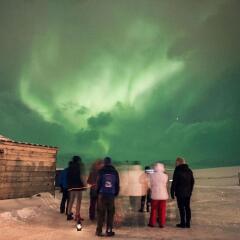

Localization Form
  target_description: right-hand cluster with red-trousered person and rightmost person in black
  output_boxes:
[139,157,194,228]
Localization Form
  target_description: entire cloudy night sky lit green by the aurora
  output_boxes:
[0,0,240,167]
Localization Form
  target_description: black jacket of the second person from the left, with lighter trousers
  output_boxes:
[67,162,84,190]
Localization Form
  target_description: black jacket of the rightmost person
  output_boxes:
[171,164,194,198]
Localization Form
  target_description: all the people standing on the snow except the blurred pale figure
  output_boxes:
[60,156,194,236]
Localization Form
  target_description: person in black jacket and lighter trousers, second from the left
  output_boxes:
[67,156,85,221]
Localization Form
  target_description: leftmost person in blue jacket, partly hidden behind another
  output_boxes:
[59,161,72,213]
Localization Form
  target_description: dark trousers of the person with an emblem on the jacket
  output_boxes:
[97,195,115,233]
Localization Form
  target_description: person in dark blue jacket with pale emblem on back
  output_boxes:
[96,157,120,237]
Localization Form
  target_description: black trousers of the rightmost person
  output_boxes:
[177,197,191,225]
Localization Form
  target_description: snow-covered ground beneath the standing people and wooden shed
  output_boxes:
[0,186,240,240]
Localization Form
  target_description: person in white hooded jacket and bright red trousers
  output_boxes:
[148,163,168,228]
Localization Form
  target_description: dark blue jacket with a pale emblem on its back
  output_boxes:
[97,165,120,197]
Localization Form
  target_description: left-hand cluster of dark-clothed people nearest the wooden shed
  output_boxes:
[60,156,120,236]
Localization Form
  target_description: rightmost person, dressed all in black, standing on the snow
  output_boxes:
[171,157,194,228]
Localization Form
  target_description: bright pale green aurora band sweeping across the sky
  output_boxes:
[20,27,183,131]
